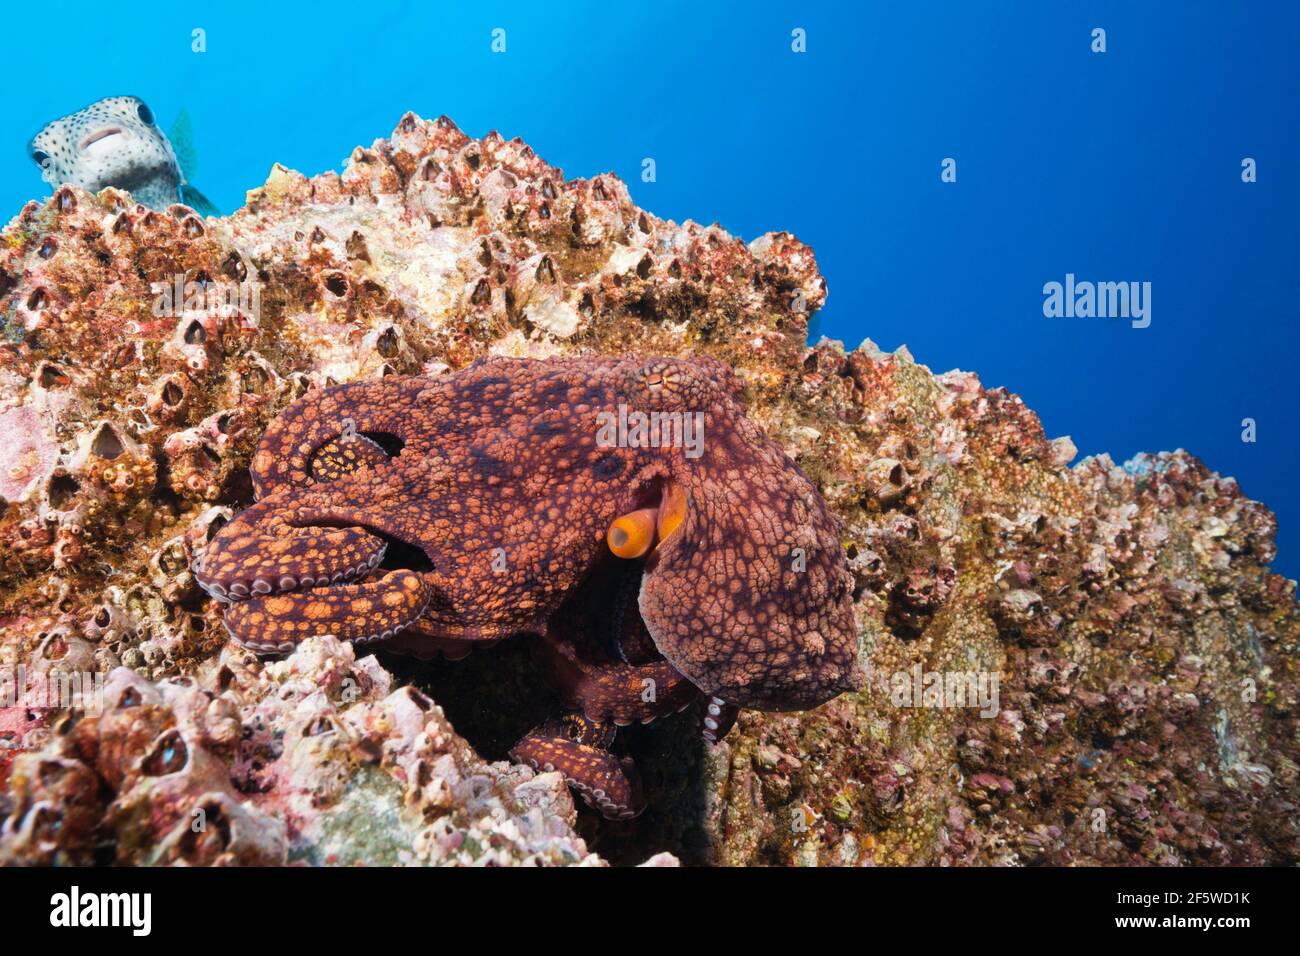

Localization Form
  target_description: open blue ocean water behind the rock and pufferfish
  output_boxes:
[0,0,1300,576]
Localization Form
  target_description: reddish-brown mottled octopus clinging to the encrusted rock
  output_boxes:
[195,355,863,818]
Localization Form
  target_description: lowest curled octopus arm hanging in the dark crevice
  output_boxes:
[510,714,645,819]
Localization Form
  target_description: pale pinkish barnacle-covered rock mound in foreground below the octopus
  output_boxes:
[0,637,601,865]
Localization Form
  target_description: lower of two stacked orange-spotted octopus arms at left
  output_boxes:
[225,568,433,653]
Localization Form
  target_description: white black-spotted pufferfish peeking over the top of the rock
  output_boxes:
[27,96,218,216]
